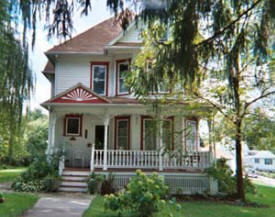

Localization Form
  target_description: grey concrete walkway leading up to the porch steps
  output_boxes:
[23,193,92,217]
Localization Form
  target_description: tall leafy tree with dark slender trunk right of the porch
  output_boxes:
[125,1,275,201]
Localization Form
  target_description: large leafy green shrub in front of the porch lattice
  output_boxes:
[105,170,168,217]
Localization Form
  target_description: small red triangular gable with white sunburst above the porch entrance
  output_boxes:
[42,83,110,106]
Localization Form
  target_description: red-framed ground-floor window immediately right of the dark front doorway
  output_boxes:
[115,117,130,150]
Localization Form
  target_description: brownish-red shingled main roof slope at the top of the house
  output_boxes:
[46,17,122,54]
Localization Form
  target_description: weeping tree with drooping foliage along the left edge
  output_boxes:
[0,0,33,163]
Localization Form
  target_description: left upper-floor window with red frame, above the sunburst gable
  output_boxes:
[91,62,108,95]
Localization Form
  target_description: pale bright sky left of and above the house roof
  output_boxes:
[28,0,112,114]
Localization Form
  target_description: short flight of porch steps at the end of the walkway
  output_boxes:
[58,169,90,192]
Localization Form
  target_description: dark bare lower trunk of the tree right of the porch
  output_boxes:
[235,121,245,202]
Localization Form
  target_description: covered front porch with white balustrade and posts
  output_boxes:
[48,107,212,173]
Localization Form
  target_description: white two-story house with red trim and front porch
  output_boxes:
[42,18,218,193]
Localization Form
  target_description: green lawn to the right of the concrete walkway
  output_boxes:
[83,185,275,217]
